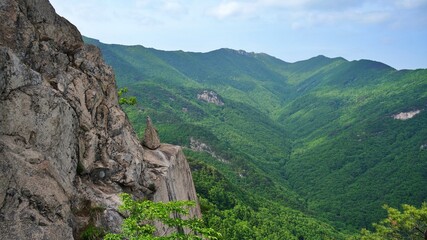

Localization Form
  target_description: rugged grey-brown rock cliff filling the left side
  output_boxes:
[0,0,200,239]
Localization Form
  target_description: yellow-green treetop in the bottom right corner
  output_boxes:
[361,203,427,240]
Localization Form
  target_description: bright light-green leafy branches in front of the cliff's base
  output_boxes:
[104,193,220,240]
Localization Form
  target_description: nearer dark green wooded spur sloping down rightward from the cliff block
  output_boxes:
[188,157,346,240]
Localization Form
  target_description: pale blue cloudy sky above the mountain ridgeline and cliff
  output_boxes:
[51,0,427,69]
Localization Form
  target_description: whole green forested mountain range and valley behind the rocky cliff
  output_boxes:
[85,38,427,239]
